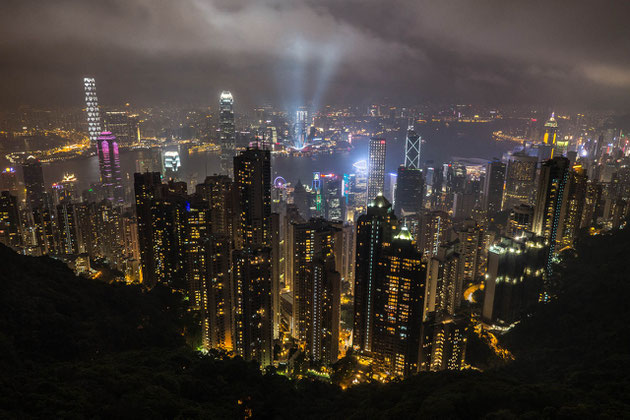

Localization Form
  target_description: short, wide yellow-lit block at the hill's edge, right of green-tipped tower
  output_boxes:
[419,312,469,372]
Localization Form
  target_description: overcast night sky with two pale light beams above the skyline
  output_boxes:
[0,0,630,111]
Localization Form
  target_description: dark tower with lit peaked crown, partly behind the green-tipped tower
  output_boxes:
[352,194,397,352]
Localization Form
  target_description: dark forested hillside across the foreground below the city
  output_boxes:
[0,232,630,419]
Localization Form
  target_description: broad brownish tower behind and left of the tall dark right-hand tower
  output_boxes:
[503,153,538,210]
